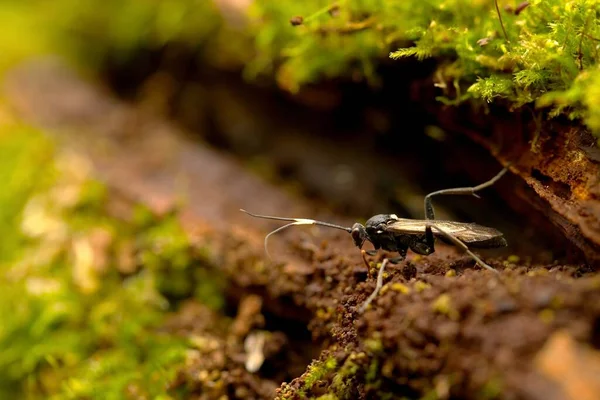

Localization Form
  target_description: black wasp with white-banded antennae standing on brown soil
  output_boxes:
[240,166,508,311]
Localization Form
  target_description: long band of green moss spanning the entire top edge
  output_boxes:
[0,0,600,140]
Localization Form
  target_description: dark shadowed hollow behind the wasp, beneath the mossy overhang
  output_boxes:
[94,45,570,264]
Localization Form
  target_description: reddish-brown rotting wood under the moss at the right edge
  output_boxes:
[413,82,600,269]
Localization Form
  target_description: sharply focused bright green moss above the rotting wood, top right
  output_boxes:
[390,0,600,135]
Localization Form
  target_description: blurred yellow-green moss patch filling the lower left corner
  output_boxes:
[0,124,223,399]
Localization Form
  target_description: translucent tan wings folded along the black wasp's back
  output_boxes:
[386,219,502,244]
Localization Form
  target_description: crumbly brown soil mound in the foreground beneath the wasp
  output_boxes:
[279,248,600,399]
